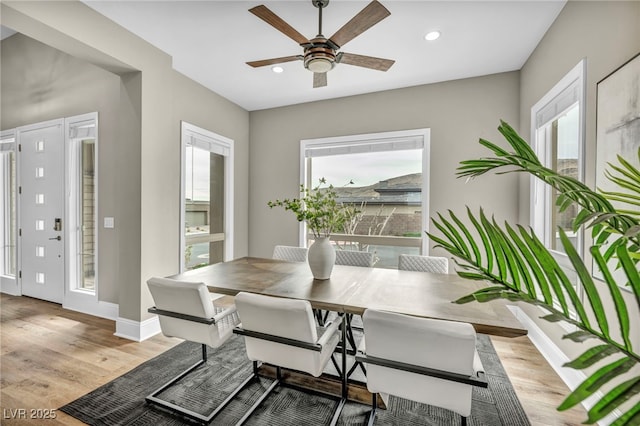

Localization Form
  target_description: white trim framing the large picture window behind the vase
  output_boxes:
[298,128,431,254]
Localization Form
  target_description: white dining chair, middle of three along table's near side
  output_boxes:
[234,292,347,425]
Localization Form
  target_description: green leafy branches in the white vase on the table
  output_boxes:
[267,178,355,238]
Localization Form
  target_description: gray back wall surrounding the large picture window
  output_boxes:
[249,72,520,257]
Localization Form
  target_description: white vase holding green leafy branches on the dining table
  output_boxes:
[267,178,351,280]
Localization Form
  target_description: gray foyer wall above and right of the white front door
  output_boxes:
[0,34,127,302]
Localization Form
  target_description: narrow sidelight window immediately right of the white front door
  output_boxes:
[67,113,98,294]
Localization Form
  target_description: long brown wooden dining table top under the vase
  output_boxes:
[170,257,527,337]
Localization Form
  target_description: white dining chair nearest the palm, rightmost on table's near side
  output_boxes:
[356,309,488,425]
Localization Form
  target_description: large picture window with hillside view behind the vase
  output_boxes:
[301,129,429,268]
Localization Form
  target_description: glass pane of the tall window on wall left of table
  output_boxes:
[185,145,224,269]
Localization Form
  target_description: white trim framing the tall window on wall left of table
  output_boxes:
[179,121,235,272]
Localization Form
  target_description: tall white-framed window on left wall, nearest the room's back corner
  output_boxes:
[180,122,233,270]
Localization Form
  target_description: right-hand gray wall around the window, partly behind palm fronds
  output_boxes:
[520,1,640,370]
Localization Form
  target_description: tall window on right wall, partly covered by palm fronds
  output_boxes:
[531,61,584,256]
